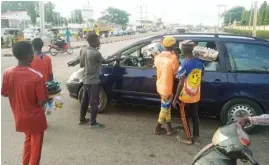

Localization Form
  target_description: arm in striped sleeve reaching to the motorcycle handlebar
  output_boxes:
[237,114,269,126]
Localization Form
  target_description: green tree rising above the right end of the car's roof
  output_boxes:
[223,6,245,26]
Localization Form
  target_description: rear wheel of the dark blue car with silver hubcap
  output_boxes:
[220,98,263,132]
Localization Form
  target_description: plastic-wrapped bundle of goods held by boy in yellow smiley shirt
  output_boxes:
[192,46,219,61]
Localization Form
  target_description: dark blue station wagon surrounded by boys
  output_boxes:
[67,33,269,123]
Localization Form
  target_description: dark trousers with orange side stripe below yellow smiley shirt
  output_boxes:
[180,102,199,138]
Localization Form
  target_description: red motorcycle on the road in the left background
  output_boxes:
[49,38,73,56]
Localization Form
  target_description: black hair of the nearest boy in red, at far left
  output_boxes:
[12,41,34,60]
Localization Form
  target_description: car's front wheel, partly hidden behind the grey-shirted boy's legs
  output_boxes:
[78,87,108,113]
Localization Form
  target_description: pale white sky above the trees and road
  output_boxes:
[52,0,269,25]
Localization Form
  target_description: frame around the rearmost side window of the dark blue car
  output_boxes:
[223,40,269,74]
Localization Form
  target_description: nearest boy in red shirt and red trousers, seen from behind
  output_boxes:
[1,41,48,165]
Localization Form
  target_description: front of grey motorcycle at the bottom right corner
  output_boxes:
[192,123,259,165]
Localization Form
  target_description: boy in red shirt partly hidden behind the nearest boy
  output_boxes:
[31,38,53,82]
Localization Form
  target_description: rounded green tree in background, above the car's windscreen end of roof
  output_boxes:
[103,7,130,26]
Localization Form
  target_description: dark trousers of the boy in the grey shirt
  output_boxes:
[80,84,100,125]
